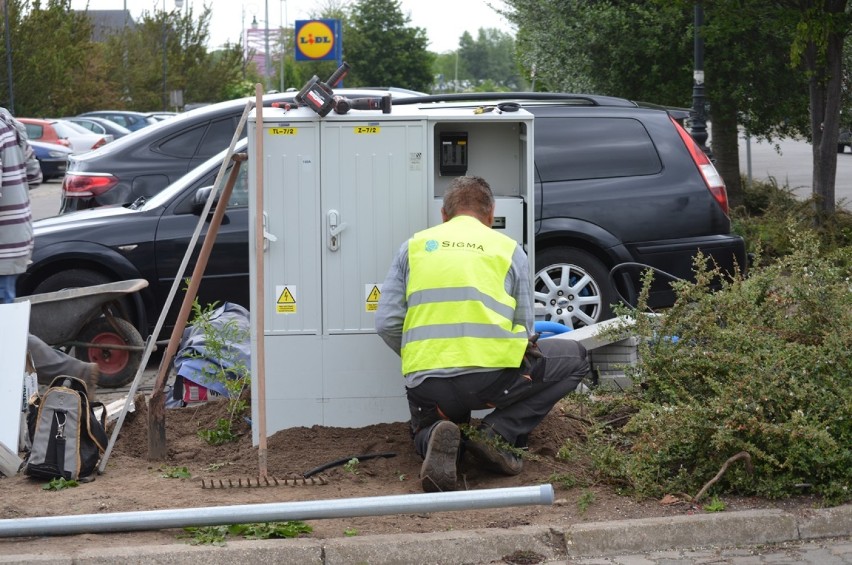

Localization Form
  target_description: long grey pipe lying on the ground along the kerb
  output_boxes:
[0,484,553,537]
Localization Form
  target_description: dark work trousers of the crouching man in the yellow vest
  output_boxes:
[406,338,589,457]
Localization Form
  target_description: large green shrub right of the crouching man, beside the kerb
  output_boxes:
[571,225,852,503]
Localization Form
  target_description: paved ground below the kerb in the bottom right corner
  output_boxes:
[560,538,852,565]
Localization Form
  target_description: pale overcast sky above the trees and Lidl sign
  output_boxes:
[71,0,514,53]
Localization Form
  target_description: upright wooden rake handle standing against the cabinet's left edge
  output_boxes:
[251,84,267,478]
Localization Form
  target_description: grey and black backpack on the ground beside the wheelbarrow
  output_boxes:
[24,376,107,480]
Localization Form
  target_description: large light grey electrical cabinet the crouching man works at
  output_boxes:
[248,102,533,443]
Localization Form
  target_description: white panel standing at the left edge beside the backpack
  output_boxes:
[0,301,30,453]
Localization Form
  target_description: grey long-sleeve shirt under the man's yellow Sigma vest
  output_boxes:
[376,234,534,388]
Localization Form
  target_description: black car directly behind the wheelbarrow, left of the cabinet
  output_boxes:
[17,140,250,348]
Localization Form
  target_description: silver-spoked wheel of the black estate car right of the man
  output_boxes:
[535,246,616,329]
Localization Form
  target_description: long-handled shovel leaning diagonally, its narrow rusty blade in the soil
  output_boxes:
[148,153,247,461]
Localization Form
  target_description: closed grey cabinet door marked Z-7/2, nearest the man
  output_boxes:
[321,121,426,334]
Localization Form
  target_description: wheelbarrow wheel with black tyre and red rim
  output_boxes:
[74,316,145,388]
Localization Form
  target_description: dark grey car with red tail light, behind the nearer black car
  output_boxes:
[59,89,426,214]
